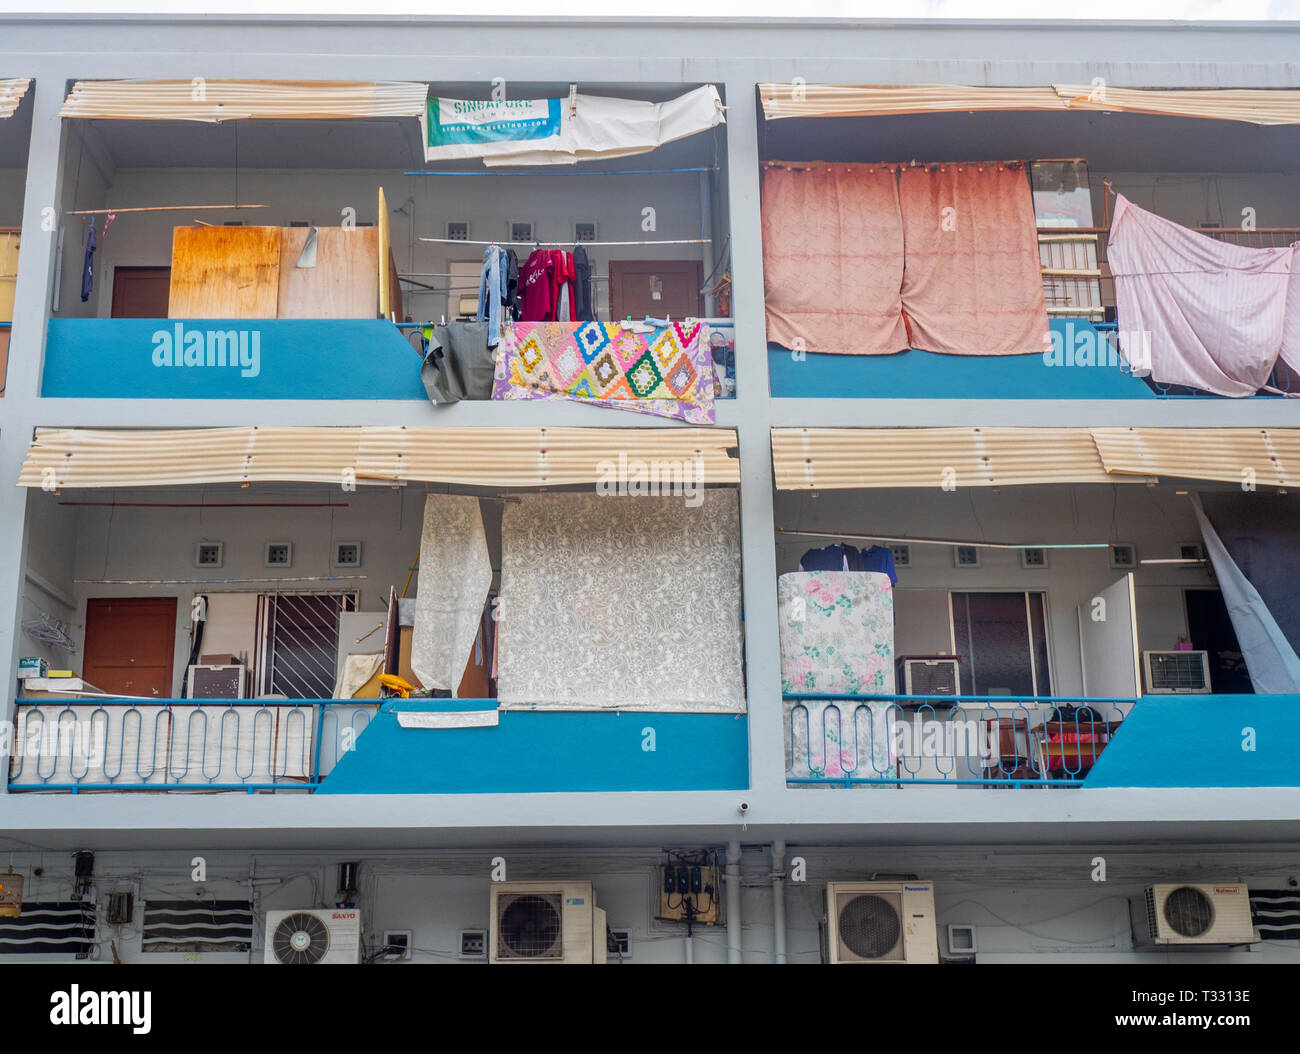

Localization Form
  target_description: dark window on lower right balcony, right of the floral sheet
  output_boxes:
[949,593,1052,695]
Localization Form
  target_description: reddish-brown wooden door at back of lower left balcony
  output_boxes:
[82,597,176,699]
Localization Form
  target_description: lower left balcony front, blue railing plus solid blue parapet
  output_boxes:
[9,697,748,794]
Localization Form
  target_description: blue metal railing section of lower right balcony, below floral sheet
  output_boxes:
[784,694,1136,788]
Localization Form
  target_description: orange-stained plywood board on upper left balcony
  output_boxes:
[168,227,280,318]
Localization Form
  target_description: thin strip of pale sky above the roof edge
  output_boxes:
[0,0,1300,21]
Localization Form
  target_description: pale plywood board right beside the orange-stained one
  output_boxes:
[280,227,380,318]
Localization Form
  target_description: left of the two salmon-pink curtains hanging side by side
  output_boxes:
[763,165,904,355]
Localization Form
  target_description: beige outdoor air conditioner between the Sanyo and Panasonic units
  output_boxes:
[488,881,606,963]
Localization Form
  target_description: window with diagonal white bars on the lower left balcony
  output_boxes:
[257,593,356,699]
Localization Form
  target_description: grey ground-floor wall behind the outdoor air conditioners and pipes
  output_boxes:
[0,847,1300,963]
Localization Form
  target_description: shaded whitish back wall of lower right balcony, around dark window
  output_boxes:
[776,485,1214,695]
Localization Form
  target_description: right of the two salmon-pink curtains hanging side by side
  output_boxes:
[898,164,1048,355]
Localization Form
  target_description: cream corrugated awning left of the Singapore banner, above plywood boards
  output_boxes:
[59,78,429,122]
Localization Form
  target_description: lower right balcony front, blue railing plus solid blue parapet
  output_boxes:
[785,694,1300,790]
